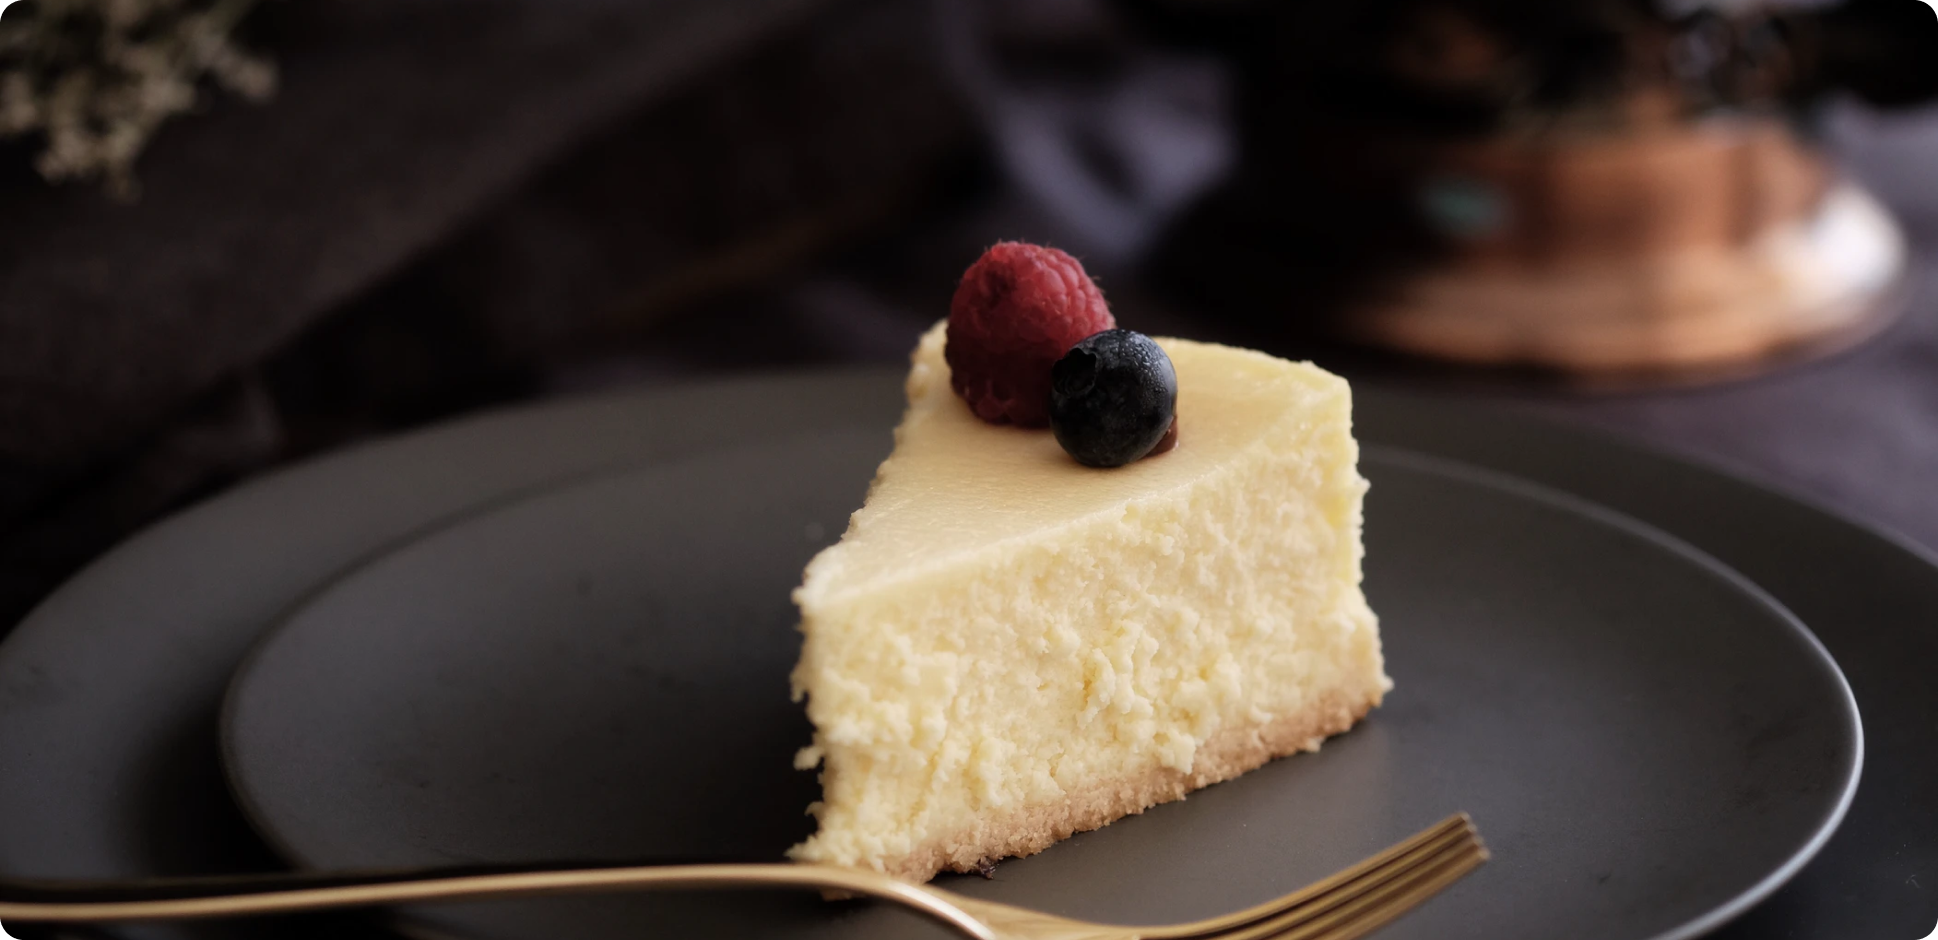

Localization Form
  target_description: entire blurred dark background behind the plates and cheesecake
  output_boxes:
[0,0,1938,624]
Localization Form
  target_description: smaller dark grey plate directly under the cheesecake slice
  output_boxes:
[225,434,1862,940]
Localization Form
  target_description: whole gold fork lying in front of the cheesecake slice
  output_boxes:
[0,814,1486,940]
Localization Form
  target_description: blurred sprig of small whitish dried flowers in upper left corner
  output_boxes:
[0,0,275,196]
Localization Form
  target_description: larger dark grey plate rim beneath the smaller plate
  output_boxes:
[0,370,1938,940]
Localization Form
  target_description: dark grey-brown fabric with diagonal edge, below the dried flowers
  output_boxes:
[0,0,816,467]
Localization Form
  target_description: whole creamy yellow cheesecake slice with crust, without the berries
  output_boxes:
[791,326,1391,880]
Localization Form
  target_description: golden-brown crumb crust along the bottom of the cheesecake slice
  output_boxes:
[884,688,1384,882]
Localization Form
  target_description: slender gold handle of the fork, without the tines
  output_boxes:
[0,864,994,940]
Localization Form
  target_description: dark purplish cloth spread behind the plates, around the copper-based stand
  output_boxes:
[0,0,1938,627]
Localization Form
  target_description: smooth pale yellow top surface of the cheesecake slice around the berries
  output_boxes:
[797,324,1351,605]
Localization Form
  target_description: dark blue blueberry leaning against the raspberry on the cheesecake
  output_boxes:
[1050,329,1178,467]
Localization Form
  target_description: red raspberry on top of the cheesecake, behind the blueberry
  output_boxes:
[942,242,1116,428]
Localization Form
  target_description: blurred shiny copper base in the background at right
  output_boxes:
[1341,118,1905,376]
